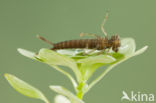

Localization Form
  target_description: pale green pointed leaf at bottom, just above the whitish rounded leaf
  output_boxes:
[50,86,84,103]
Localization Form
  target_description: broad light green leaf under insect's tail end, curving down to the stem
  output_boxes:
[38,49,81,81]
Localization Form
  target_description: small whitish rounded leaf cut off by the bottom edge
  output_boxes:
[54,95,71,103]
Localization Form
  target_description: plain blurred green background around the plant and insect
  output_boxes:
[0,0,156,103]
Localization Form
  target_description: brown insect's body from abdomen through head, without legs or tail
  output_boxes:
[51,35,120,52]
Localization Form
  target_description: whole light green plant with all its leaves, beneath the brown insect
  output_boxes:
[5,38,148,103]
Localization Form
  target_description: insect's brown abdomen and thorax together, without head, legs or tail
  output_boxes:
[52,38,109,50]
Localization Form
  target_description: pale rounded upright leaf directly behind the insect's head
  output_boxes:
[119,38,136,56]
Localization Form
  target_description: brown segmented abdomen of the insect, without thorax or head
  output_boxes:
[52,39,98,50]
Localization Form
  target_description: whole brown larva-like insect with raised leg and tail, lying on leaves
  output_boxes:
[38,13,120,52]
